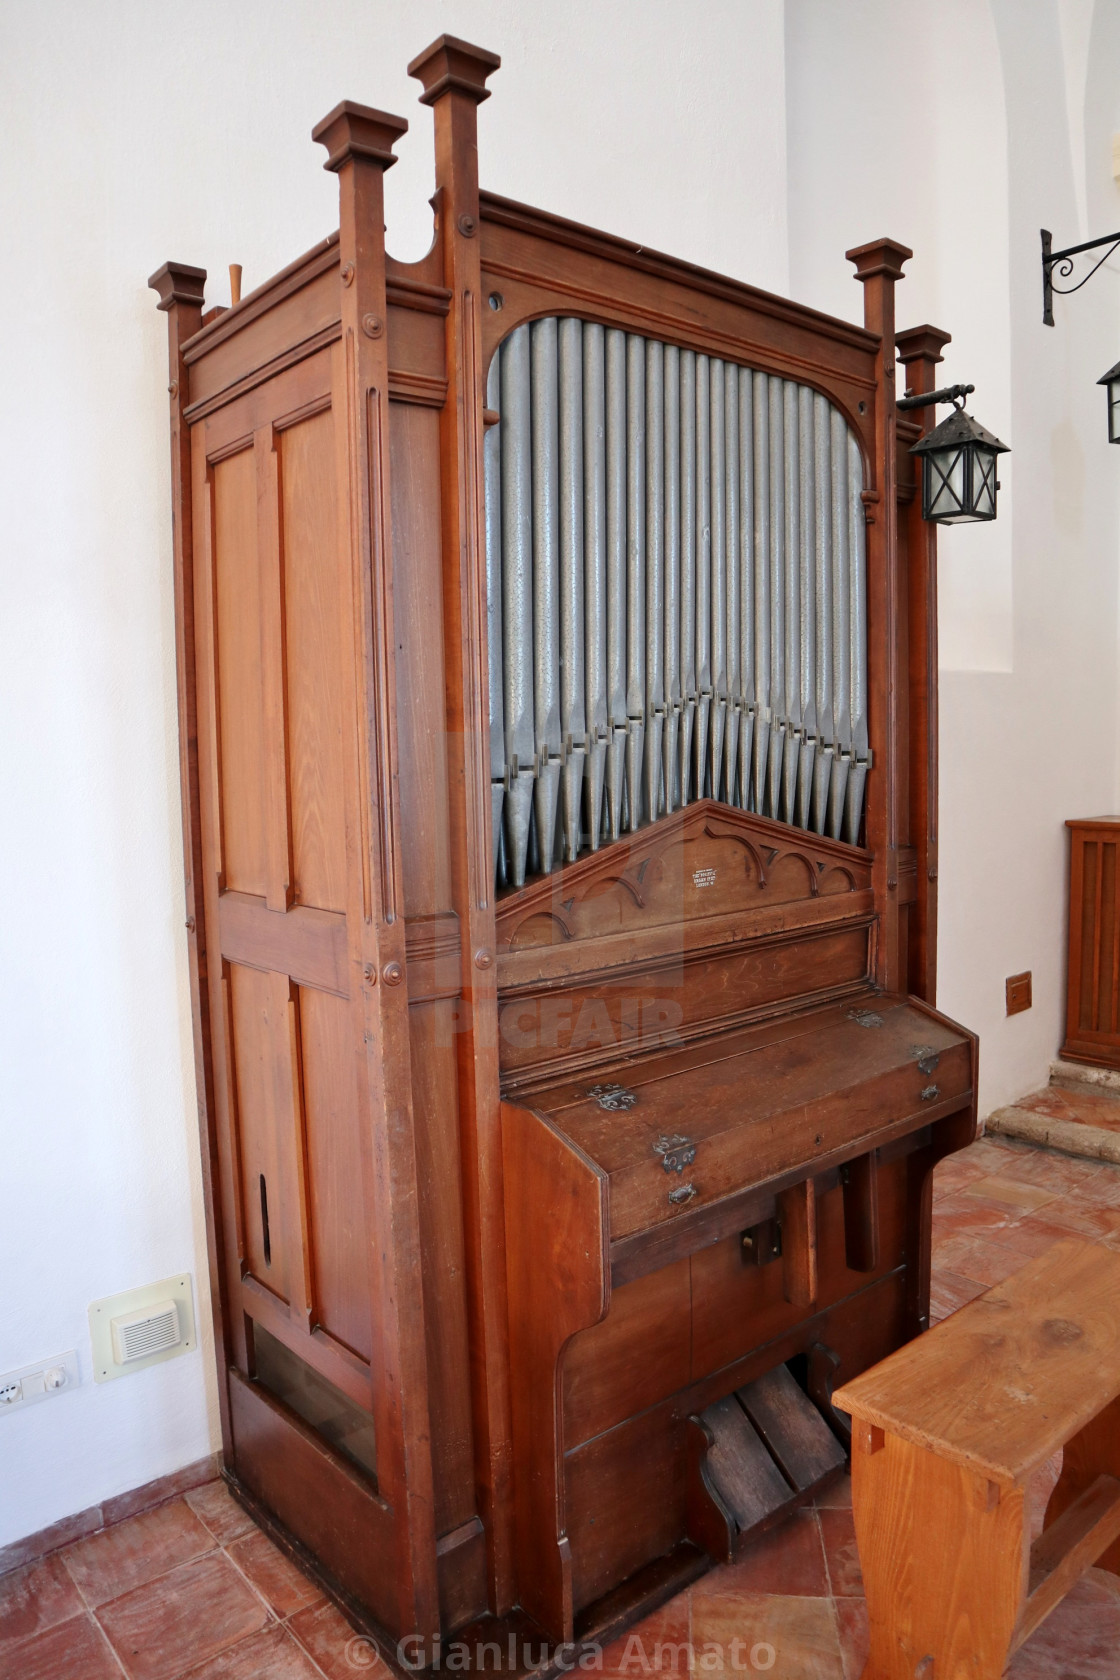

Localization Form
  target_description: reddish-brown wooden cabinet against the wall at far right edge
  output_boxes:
[1061,816,1120,1067]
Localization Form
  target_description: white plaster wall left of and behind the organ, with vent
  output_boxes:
[0,0,788,1544]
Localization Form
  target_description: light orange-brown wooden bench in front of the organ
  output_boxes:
[835,1240,1120,1680]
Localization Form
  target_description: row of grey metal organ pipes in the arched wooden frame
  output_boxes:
[485,318,870,887]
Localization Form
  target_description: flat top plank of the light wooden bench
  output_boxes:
[833,1240,1120,1487]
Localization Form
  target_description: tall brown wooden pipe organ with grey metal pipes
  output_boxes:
[151,37,976,1656]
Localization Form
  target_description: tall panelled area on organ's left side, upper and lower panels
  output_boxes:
[195,356,382,1408]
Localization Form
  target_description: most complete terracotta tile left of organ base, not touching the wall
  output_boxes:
[97,1552,269,1680]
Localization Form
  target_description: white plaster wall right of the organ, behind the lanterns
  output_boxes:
[786,0,1120,1112]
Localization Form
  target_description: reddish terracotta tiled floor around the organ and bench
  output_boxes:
[0,1128,1120,1680]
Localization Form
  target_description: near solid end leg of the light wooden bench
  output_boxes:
[851,1421,1028,1680]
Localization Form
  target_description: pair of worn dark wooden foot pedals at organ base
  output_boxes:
[690,1366,846,1561]
